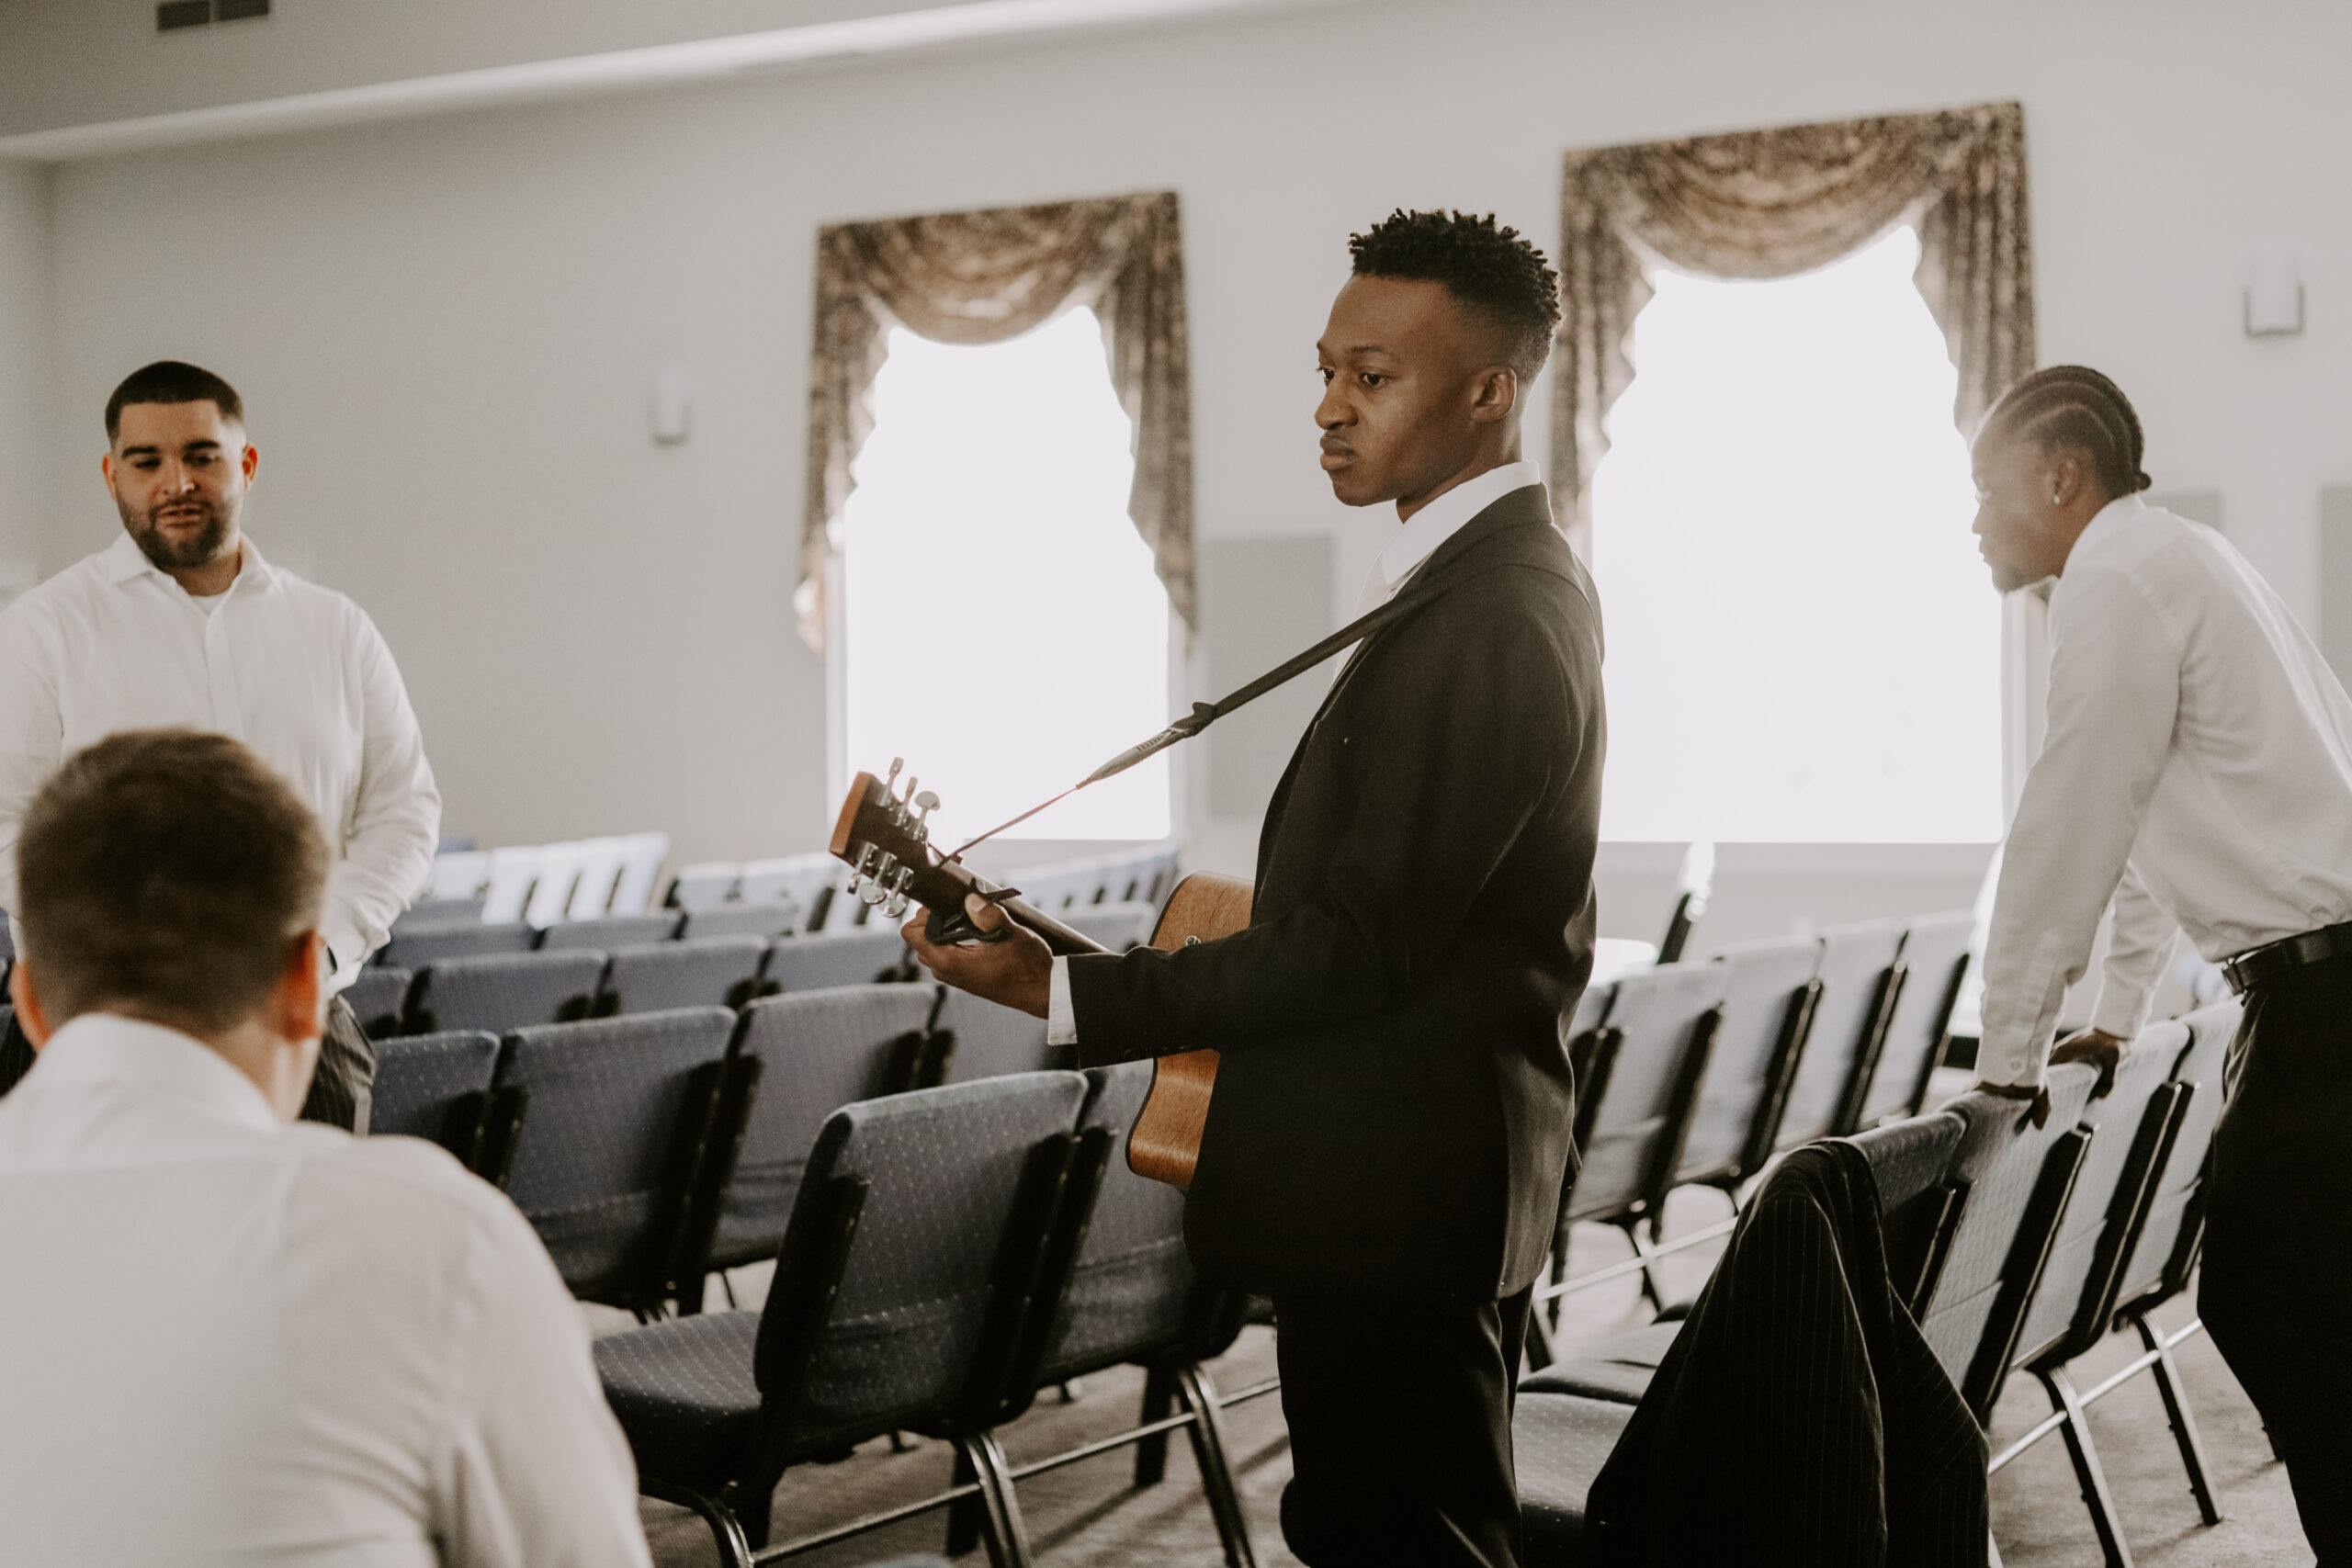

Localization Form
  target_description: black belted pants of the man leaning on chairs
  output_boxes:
[2197,959,2352,1568]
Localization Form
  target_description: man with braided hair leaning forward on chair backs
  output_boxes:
[1973,367,2352,1565]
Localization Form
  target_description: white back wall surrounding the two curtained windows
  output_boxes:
[22,0,2352,936]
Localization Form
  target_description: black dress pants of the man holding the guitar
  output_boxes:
[1275,1291,1529,1568]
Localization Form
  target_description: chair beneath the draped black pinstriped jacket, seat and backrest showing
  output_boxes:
[1512,1114,1964,1568]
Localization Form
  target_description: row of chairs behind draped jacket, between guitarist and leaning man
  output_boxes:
[1536,909,1975,1325]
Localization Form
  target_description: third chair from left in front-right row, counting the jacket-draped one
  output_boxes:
[1978,1022,2189,1568]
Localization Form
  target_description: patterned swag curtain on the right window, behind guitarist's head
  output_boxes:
[1553,104,2034,540]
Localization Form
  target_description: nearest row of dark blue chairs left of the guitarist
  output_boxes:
[374,1001,1272,1568]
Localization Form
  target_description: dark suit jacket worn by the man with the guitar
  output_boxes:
[1070,487,1604,1300]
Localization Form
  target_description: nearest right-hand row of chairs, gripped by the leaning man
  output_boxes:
[1515,1001,2239,1568]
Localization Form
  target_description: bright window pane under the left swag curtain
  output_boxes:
[842,310,1169,841]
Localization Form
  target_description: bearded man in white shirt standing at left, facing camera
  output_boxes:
[0,360,440,1134]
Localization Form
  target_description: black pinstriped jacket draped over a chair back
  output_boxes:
[1580,1138,1987,1568]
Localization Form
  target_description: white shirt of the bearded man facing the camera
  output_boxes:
[0,534,440,985]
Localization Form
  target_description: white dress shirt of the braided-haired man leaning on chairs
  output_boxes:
[1978,496,2352,1084]
